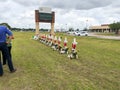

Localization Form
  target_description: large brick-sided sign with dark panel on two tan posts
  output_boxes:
[35,7,55,35]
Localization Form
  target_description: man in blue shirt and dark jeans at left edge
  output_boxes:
[0,25,16,76]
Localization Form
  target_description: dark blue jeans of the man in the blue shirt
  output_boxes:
[0,43,14,75]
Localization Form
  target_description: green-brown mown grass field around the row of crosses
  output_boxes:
[0,32,120,90]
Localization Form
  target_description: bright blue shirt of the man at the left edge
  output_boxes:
[0,26,13,43]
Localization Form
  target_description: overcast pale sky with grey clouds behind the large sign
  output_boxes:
[0,0,120,29]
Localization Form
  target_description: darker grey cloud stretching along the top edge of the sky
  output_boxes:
[43,0,113,10]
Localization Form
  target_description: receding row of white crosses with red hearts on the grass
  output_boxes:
[40,34,78,59]
